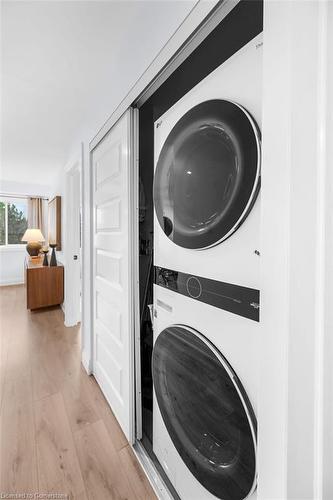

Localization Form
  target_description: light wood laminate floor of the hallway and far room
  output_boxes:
[0,286,156,500]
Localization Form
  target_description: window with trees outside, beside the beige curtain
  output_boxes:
[0,197,28,245]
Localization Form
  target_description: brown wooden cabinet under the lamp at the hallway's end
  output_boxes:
[25,257,64,309]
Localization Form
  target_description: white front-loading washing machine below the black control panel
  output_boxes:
[152,284,258,500]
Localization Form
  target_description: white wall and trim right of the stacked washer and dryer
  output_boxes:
[258,1,333,500]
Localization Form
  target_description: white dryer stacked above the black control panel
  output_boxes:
[154,35,262,288]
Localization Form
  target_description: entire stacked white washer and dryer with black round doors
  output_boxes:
[152,35,262,500]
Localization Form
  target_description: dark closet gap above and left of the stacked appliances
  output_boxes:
[134,0,263,492]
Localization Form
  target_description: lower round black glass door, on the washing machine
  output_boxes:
[152,325,257,500]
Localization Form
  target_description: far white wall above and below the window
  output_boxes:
[0,179,51,286]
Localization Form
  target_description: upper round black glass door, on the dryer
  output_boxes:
[154,99,260,249]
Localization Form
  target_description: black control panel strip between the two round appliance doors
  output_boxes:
[154,266,260,321]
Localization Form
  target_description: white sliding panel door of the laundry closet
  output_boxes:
[92,110,135,441]
